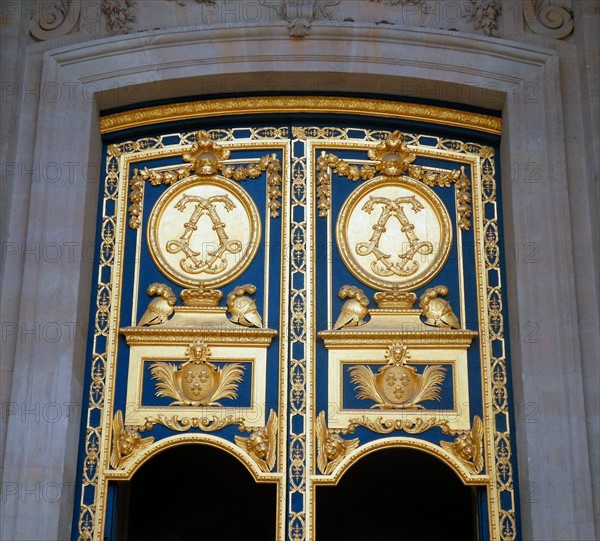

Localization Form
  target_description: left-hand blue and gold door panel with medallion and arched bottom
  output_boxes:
[77,130,290,539]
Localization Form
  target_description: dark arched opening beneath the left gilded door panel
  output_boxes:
[117,444,277,541]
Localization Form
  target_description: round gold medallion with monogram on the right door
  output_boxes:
[336,177,452,291]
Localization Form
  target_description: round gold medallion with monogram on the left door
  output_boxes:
[148,175,261,287]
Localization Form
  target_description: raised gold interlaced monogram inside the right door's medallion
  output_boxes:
[355,195,433,276]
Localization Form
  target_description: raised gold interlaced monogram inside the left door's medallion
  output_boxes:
[166,195,242,274]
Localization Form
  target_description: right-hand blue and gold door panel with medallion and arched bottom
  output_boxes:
[307,130,506,539]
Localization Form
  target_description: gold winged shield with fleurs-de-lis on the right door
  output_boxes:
[349,342,446,409]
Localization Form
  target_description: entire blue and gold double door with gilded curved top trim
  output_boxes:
[73,97,518,541]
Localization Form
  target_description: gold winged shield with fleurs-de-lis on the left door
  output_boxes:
[150,341,245,407]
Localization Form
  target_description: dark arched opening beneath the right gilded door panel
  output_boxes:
[316,448,477,541]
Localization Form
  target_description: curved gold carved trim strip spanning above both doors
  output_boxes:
[100,96,502,135]
